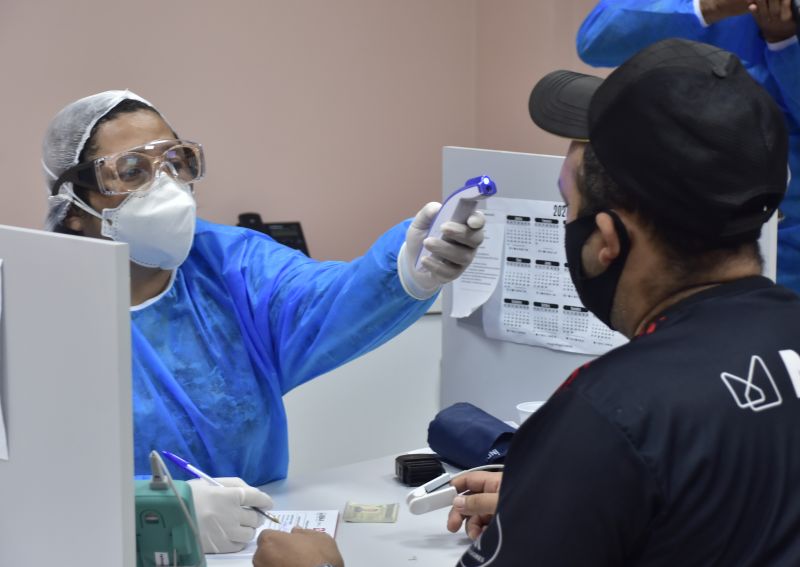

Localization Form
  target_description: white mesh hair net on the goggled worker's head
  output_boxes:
[42,90,160,230]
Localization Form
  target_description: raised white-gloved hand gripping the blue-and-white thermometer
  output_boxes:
[397,203,486,299]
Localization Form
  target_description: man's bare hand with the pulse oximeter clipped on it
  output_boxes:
[447,471,503,540]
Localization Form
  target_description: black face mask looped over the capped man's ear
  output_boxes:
[564,210,631,329]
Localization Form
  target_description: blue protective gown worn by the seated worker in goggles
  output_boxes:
[131,219,433,485]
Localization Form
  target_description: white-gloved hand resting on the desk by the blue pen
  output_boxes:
[189,477,272,553]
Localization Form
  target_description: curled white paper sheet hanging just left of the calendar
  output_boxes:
[450,210,505,319]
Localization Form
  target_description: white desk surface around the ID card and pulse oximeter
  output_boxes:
[207,456,469,567]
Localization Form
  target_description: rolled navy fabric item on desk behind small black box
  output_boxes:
[428,402,515,469]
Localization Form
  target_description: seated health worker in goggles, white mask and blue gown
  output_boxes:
[42,91,484,552]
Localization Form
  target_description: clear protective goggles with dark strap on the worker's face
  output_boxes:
[52,140,205,195]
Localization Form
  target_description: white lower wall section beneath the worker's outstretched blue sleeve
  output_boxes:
[284,313,442,478]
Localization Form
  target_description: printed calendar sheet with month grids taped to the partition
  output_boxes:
[483,197,627,355]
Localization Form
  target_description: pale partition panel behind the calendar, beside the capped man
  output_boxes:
[441,147,591,421]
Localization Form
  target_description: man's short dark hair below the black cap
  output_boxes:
[577,144,763,275]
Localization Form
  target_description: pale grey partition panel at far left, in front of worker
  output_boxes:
[0,226,135,567]
